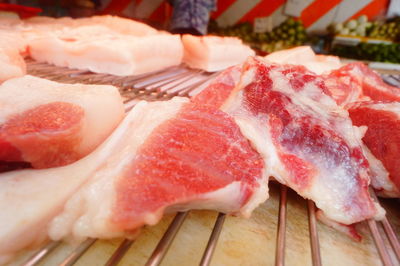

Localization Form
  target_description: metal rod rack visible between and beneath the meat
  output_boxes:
[18,61,400,266]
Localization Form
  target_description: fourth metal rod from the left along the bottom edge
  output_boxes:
[146,212,188,266]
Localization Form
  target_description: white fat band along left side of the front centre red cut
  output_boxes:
[49,98,188,240]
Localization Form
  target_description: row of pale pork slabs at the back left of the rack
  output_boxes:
[0,16,255,82]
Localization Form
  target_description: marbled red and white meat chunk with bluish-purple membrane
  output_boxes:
[193,59,384,224]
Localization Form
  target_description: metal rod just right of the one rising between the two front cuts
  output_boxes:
[307,200,322,266]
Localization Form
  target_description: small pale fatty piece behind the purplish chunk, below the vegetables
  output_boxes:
[264,46,341,74]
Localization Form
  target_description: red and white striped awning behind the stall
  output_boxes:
[98,0,389,31]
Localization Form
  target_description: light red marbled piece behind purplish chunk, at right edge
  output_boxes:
[325,62,400,106]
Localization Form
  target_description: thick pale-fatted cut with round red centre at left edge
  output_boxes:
[0,75,124,168]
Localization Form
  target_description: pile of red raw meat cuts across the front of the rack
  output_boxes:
[0,16,400,262]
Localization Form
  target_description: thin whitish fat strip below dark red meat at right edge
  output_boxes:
[362,145,400,197]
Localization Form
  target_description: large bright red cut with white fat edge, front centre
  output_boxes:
[50,99,268,240]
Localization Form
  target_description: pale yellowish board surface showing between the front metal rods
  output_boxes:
[7,184,400,266]
